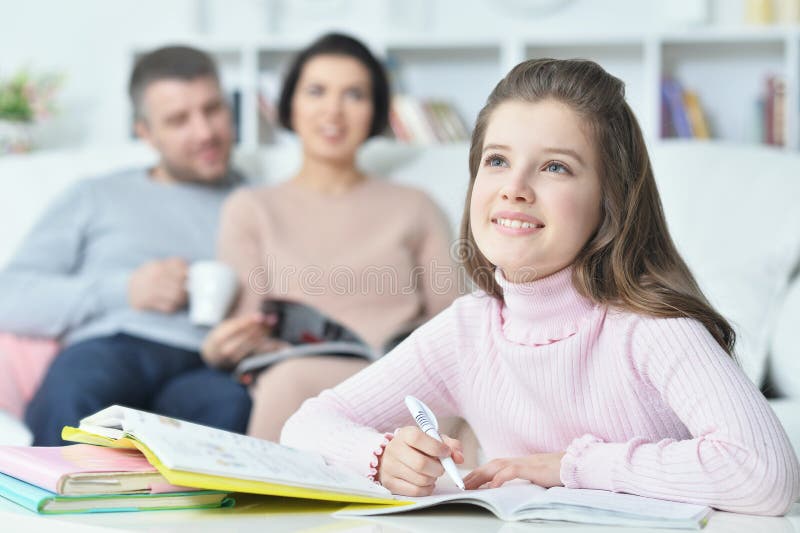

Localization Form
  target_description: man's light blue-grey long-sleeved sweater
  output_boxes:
[0,168,241,350]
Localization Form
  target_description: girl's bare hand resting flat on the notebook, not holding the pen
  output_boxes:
[464,452,564,490]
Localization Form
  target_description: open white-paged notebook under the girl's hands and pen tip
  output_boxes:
[334,482,713,529]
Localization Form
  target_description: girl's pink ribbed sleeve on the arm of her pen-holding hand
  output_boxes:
[281,300,463,477]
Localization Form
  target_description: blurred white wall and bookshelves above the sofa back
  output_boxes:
[0,0,800,153]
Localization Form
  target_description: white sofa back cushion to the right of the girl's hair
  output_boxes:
[651,141,800,385]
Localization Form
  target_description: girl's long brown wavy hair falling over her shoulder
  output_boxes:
[460,59,736,356]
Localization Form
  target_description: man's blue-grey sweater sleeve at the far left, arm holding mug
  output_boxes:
[0,182,131,337]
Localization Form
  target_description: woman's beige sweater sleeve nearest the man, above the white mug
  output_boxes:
[217,189,267,316]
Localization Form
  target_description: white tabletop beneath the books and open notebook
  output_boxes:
[0,495,800,533]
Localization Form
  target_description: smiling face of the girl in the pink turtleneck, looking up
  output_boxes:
[470,100,601,283]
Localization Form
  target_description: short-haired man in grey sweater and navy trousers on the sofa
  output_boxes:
[0,47,250,446]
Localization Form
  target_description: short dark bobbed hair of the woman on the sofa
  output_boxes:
[278,33,390,137]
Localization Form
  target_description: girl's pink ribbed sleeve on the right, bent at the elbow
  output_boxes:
[561,318,800,515]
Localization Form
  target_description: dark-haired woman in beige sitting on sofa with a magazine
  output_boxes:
[203,34,458,441]
